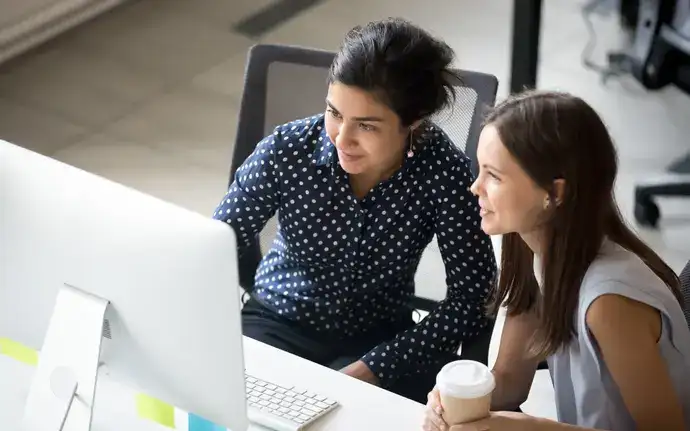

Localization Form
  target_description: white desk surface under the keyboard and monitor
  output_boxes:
[0,337,424,431]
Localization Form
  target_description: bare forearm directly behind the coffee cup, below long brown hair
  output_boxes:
[491,313,539,410]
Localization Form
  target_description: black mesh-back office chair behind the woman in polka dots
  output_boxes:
[228,44,498,364]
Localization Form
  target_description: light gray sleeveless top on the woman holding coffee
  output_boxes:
[535,241,690,431]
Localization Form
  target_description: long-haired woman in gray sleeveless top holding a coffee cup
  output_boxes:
[424,92,690,431]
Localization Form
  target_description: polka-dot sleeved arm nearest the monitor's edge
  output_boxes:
[213,129,281,253]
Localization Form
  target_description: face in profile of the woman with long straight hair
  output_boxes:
[470,124,548,235]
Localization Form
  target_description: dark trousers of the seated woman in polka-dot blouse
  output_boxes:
[242,299,457,404]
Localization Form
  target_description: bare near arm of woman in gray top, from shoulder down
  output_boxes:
[464,295,686,431]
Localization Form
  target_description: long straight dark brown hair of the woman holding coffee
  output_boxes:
[486,91,682,356]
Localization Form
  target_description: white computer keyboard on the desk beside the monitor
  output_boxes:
[246,375,338,431]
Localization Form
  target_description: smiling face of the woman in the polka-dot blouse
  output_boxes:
[326,82,410,175]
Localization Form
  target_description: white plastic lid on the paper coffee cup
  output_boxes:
[436,360,496,398]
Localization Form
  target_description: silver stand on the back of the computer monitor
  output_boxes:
[23,285,109,431]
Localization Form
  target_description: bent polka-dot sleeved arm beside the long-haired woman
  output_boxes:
[362,158,496,386]
